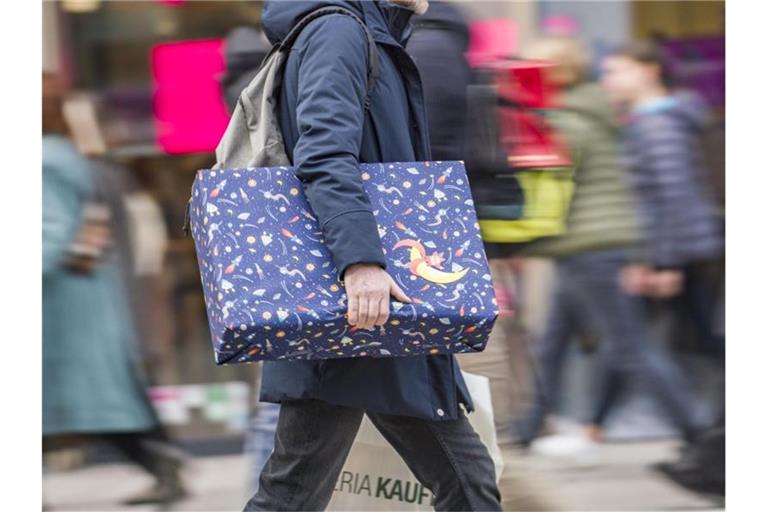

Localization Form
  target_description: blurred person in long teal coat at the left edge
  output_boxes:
[42,75,185,504]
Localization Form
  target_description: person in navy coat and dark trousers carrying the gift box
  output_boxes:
[246,0,501,510]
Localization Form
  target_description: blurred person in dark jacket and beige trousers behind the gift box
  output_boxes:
[406,6,558,511]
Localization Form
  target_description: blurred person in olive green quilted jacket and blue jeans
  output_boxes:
[515,36,700,445]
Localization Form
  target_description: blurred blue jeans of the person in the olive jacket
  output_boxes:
[517,250,699,443]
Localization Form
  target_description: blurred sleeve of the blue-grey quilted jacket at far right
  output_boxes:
[638,116,694,269]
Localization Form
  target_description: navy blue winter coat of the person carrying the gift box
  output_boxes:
[261,0,472,420]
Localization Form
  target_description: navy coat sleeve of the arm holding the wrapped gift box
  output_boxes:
[293,15,386,278]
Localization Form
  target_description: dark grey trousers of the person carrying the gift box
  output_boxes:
[245,400,501,511]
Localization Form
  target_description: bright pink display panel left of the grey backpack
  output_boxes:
[150,39,229,154]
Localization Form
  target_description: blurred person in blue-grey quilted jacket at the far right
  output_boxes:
[603,41,723,351]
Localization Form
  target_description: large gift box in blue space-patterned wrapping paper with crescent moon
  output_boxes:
[190,162,497,364]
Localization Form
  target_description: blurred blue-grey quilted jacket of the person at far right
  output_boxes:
[626,94,723,269]
